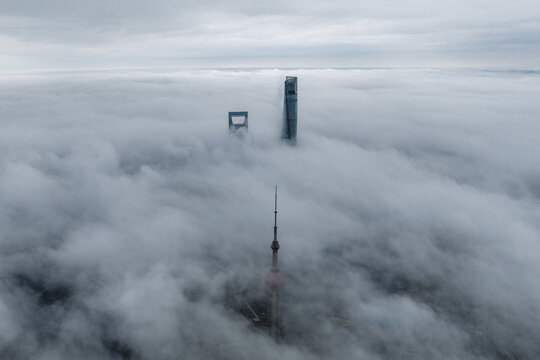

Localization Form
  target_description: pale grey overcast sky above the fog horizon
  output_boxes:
[0,0,540,73]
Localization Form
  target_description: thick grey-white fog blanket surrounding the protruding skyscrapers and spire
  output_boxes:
[0,70,540,359]
